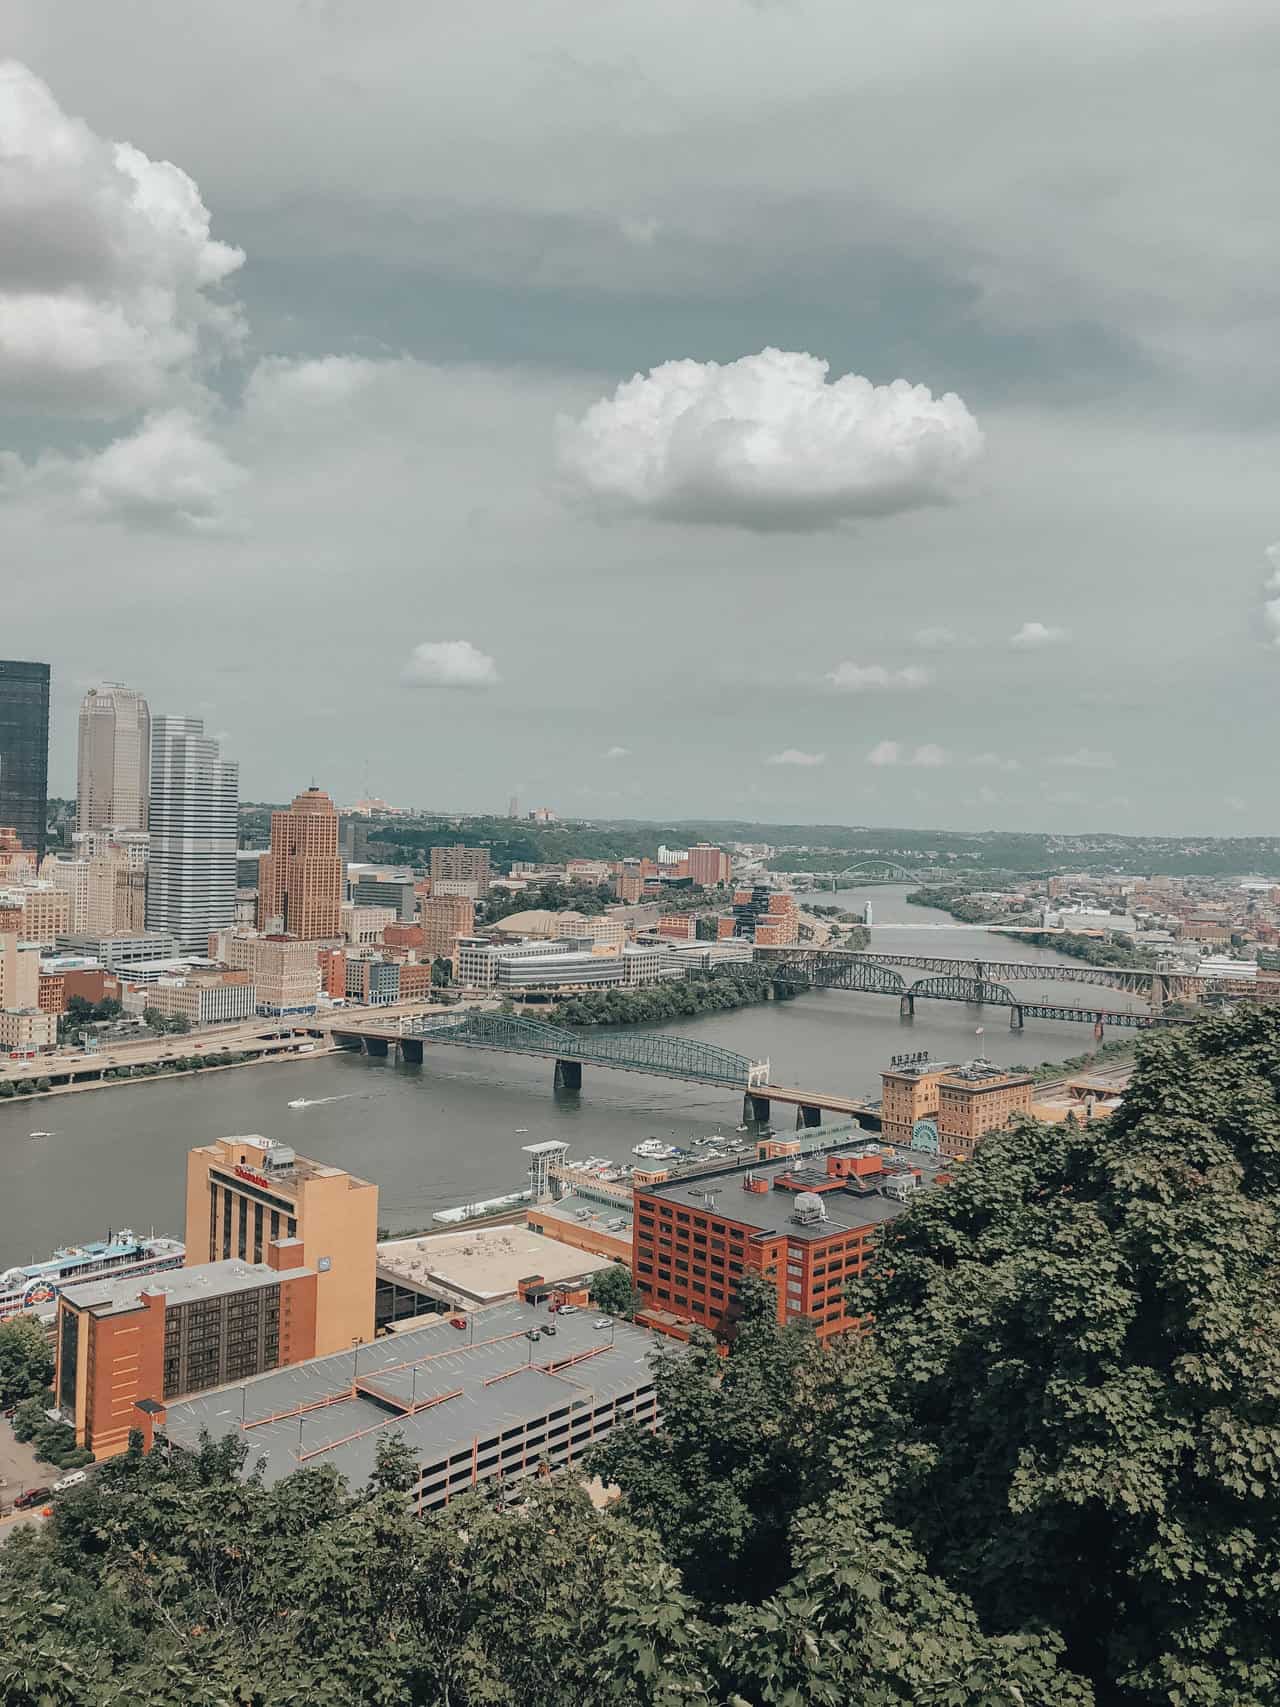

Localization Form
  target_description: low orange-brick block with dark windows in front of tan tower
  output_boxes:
[55,1239,317,1459]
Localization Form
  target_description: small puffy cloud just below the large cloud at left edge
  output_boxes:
[79,410,246,533]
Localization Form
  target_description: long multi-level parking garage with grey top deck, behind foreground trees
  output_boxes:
[147,1287,657,1511]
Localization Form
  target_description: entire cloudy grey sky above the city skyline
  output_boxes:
[0,0,1280,835]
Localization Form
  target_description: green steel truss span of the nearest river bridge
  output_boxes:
[348,1012,770,1091]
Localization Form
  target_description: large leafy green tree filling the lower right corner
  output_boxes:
[836,1009,1280,1707]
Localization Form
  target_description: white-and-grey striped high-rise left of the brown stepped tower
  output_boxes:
[147,717,241,954]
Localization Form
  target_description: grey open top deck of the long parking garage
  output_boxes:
[166,1302,654,1489]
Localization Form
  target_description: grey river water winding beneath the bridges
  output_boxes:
[0,886,1140,1270]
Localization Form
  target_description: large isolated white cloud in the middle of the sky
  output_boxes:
[558,348,983,531]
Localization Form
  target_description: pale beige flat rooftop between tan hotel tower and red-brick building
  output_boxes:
[377,1224,609,1304]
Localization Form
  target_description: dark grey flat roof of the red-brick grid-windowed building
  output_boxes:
[640,1139,952,1239]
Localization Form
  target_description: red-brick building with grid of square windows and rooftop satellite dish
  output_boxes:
[633,1127,947,1338]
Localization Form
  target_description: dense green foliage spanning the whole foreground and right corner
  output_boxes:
[0,1007,1280,1707]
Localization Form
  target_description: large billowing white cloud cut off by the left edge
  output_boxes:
[0,60,244,418]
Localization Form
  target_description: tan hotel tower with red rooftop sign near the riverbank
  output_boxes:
[186,1137,377,1357]
